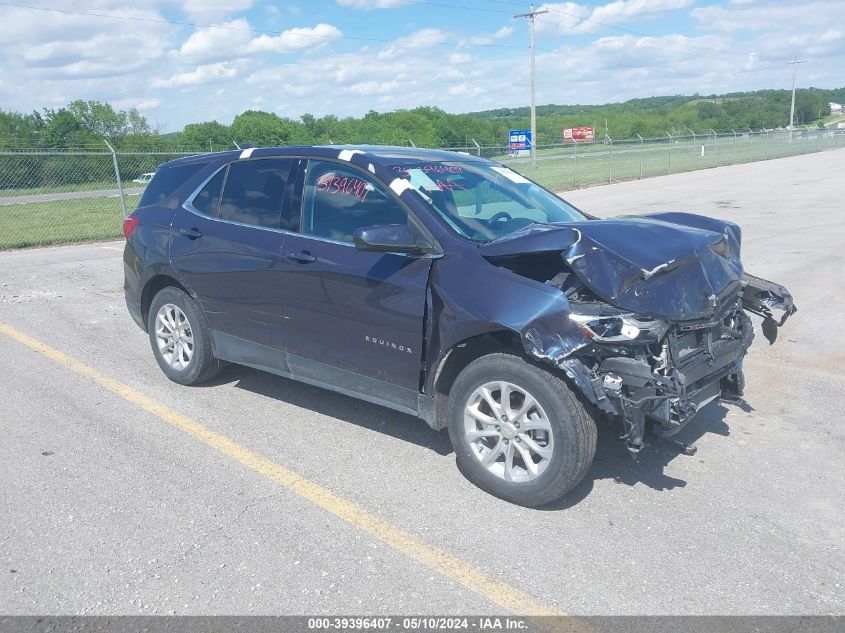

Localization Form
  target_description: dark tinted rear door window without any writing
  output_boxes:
[219,158,294,229]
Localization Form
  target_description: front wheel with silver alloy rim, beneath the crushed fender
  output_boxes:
[448,354,596,507]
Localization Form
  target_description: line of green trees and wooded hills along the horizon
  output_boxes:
[0,88,845,151]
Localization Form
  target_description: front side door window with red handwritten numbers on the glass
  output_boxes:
[300,160,408,244]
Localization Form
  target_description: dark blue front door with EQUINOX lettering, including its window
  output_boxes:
[282,160,432,408]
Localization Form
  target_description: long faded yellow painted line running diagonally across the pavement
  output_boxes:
[0,323,566,616]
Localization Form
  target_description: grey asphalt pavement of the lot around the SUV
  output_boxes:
[0,150,845,615]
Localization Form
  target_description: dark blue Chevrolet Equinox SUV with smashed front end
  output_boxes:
[124,146,795,506]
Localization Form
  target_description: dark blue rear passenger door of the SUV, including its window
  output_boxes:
[170,157,298,368]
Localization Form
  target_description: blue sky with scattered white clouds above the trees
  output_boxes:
[0,0,845,131]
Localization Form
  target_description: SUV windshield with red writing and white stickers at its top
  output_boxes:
[391,161,586,242]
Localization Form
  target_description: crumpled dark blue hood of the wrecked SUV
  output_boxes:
[479,213,743,320]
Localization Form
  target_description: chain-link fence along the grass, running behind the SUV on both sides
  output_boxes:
[0,129,845,249]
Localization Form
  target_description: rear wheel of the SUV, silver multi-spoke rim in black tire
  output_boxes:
[147,286,221,385]
